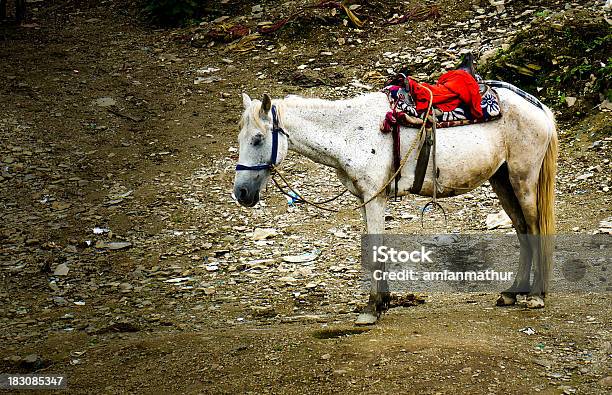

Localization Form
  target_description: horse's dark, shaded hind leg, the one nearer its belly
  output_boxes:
[489,163,533,306]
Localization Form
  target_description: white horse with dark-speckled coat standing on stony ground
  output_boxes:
[234,84,557,324]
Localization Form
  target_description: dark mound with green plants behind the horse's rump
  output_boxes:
[480,12,612,118]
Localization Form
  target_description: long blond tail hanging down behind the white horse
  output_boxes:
[537,106,559,292]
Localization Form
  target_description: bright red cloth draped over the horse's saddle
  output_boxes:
[408,70,483,119]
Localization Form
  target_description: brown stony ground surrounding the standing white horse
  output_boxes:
[0,0,612,394]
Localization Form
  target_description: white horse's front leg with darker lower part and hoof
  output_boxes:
[355,195,389,325]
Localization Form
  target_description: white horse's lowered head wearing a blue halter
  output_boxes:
[234,93,288,207]
